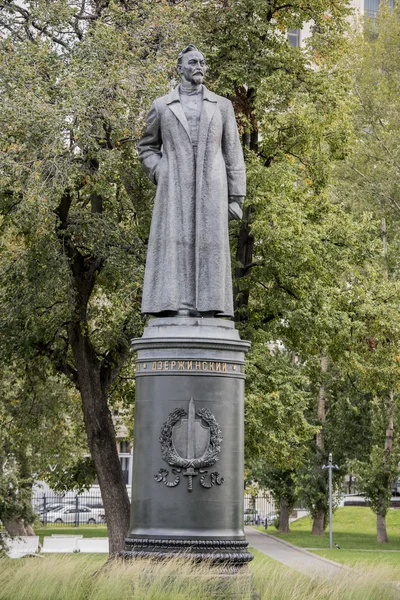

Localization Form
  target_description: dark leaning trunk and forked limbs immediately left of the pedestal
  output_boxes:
[56,189,130,557]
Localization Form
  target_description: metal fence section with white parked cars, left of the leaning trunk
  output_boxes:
[32,492,106,527]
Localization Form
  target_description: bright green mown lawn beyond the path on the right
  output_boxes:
[257,506,400,548]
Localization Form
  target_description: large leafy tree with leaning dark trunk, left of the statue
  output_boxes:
[0,0,192,555]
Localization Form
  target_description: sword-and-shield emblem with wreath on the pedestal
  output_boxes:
[154,398,224,492]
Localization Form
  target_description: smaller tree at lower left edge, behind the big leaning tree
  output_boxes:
[0,363,87,535]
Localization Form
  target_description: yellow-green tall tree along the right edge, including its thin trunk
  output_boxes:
[330,4,400,542]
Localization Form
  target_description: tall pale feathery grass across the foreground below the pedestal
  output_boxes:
[0,554,400,600]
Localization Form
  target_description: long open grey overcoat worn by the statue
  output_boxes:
[138,86,246,315]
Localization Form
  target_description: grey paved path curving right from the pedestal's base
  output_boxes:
[246,527,350,578]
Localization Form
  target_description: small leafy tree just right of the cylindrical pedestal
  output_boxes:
[245,346,318,533]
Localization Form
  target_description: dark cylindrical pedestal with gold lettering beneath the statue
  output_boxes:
[124,317,253,567]
